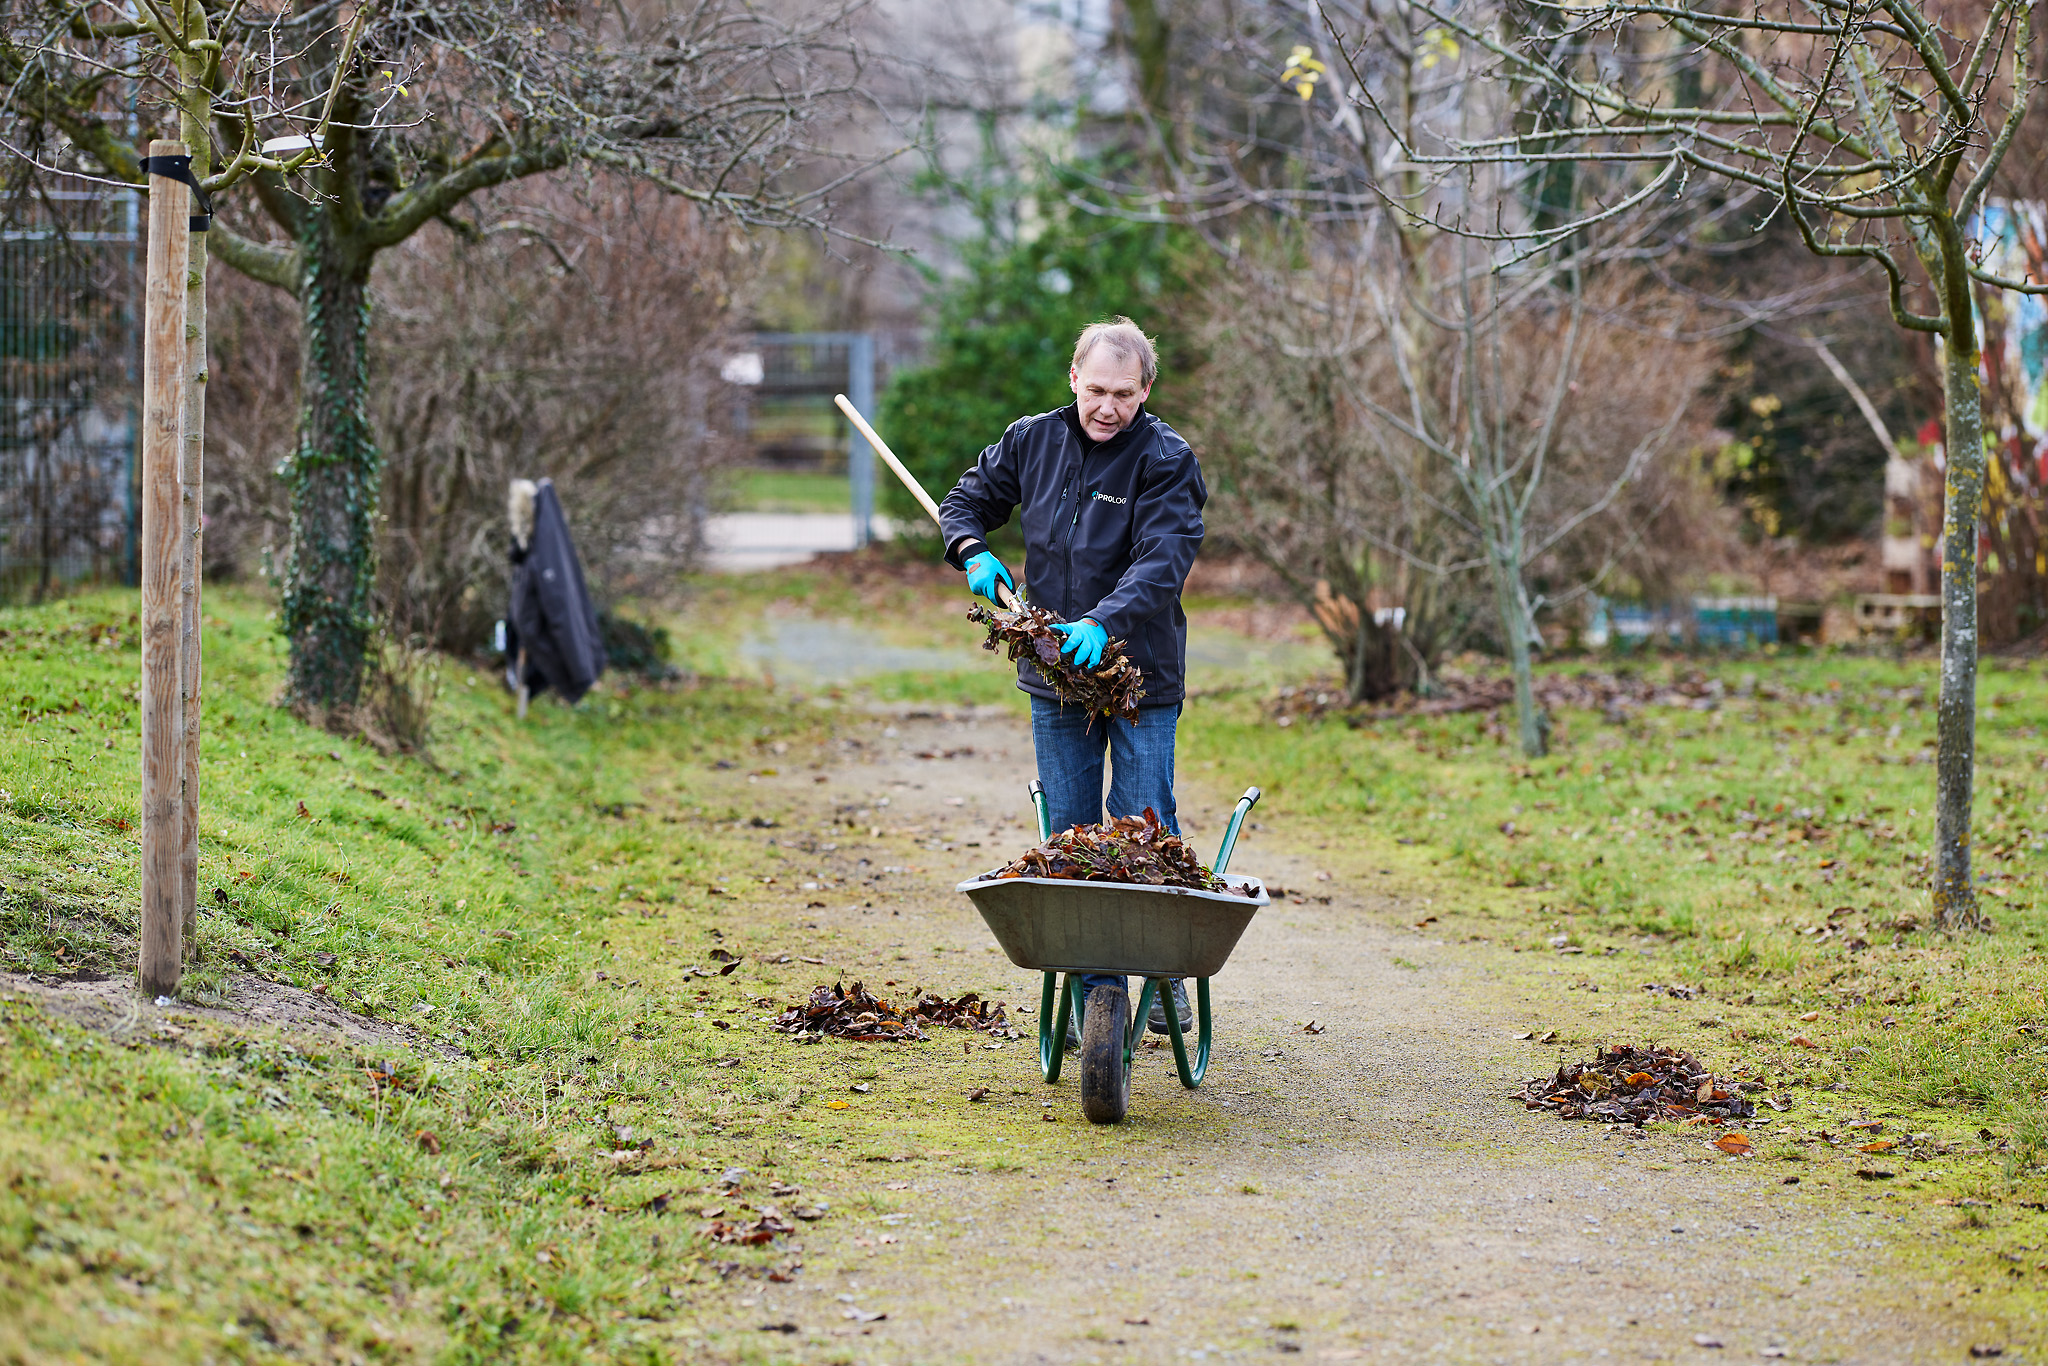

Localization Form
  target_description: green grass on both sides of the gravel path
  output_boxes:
[12,567,2048,1362]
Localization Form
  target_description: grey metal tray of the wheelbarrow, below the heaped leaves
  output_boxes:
[958,874,1270,977]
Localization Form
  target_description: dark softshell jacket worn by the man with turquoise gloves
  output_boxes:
[938,403,1208,707]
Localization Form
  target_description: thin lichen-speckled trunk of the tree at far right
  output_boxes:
[1933,323,1985,930]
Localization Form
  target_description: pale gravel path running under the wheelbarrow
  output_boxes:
[679,715,2021,1364]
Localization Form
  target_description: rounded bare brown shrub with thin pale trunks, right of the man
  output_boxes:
[1192,219,1712,754]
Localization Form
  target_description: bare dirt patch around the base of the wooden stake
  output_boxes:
[0,971,436,1057]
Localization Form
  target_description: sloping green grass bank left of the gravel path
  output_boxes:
[0,594,847,1362]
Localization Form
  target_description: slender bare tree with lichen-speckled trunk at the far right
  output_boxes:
[1321,0,2048,930]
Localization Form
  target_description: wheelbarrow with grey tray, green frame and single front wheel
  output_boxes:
[958,778,1268,1124]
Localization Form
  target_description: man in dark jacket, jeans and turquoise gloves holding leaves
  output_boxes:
[940,317,1208,1032]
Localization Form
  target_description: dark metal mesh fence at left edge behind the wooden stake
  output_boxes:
[0,190,137,600]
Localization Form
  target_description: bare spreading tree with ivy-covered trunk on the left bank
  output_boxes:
[0,0,888,709]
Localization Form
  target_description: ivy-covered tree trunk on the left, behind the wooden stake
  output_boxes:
[281,203,383,711]
